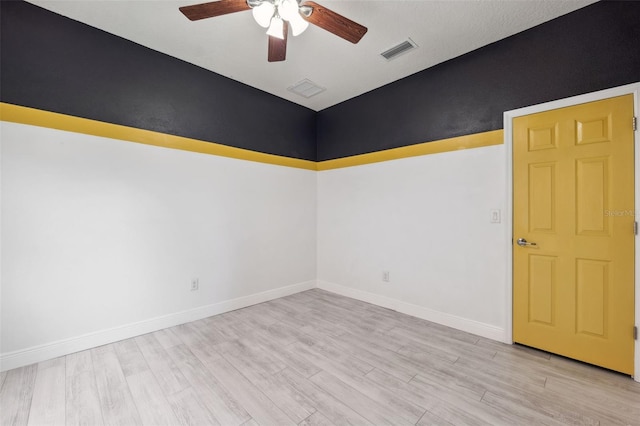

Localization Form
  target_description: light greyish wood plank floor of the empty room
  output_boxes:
[0,290,640,426]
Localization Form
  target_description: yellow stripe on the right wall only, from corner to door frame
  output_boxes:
[317,130,504,171]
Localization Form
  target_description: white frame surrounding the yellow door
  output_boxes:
[504,82,640,382]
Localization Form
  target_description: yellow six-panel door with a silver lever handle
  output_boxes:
[513,95,635,374]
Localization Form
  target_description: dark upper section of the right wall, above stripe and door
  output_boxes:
[317,1,640,161]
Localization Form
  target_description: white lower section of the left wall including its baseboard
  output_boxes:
[0,122,316,370]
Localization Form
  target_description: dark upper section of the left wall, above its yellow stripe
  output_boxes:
[0,1,316,160]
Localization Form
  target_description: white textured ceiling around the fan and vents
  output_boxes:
[25,0,594,111]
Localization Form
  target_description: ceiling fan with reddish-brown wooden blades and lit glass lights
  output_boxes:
[179,0,367,62]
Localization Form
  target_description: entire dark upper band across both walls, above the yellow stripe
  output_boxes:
[0,1,640,161]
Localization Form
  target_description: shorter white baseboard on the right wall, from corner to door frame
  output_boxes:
[318,280,505,342]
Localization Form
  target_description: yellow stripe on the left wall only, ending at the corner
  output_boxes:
[0,102,316,170]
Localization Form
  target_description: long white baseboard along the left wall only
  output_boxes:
[0,281,316,371]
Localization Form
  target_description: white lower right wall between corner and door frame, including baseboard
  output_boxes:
[318,145,506,340]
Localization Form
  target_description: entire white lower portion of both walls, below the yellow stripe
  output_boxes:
[0,122,507,370]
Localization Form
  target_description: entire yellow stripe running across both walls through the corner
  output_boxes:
[0,102,503,171]
